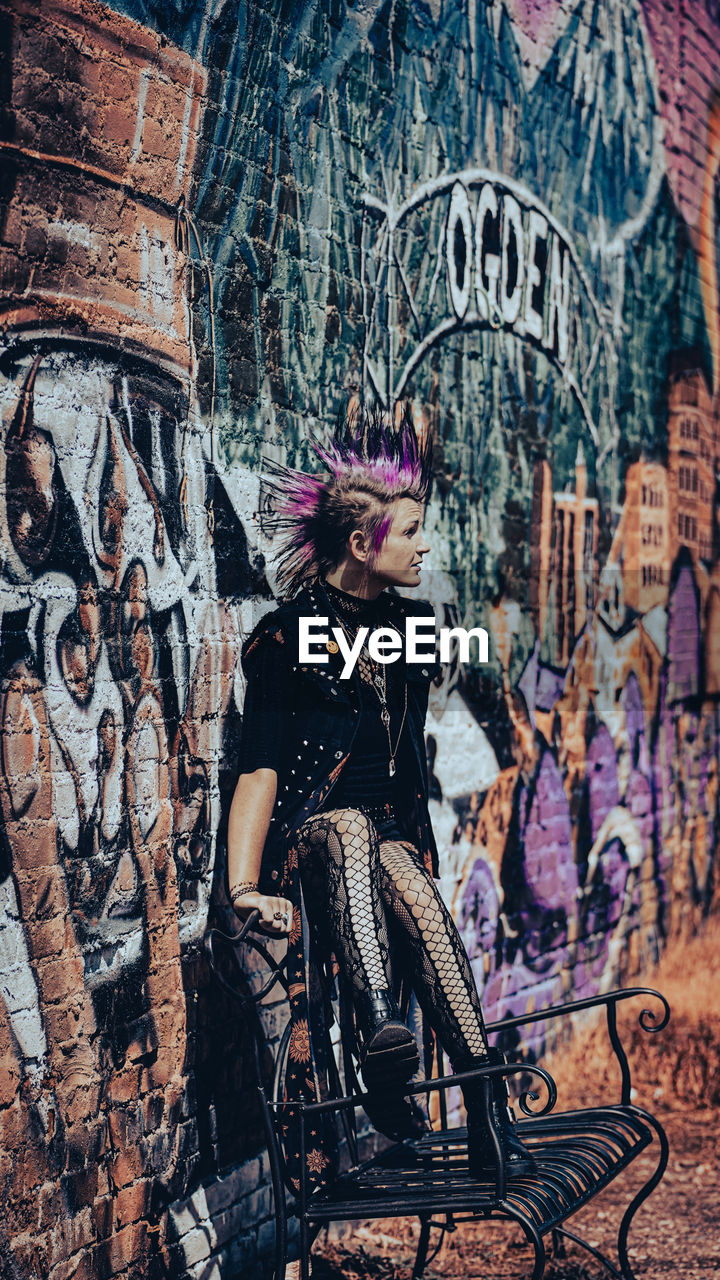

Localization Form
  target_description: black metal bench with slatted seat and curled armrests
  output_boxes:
[206,913,670,1280]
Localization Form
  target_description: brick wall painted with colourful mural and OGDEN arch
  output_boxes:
[0,0,720,1280]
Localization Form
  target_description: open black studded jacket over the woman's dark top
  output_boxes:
[242,580,437,892]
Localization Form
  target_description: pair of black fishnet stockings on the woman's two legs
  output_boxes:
[297,809,487,1071]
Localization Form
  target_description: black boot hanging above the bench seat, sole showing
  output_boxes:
[355,989,428,1140]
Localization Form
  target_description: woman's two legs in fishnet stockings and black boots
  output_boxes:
[297,809,533,1176]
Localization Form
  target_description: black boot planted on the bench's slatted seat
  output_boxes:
[462,1048,537,1180]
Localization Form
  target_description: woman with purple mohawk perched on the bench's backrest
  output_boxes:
[228,410,534,1180]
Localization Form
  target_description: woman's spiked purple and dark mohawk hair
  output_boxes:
[266,406,433,598]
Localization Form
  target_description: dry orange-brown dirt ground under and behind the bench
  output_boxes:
[307,922,720,1280]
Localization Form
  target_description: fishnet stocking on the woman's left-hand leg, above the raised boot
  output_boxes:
[297,809,392,992]
